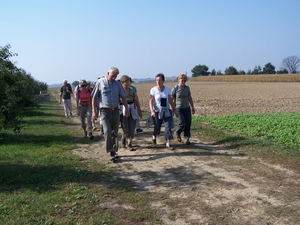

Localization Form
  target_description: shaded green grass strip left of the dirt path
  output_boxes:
[0,98,163,224]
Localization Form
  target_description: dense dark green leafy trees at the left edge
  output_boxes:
[0,45,48,132]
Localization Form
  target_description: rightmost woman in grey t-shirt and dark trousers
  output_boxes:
[171,74,195,145]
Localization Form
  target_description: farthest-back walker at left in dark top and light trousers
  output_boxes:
[58,80,73,118]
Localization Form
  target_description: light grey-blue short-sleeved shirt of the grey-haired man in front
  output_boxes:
[92,77,126,108]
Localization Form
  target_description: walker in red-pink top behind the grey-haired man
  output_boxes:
[76,80,94,140]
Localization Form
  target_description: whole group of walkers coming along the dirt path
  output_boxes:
[59,67,195,161]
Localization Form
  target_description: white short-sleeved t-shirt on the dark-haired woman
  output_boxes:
[150,86,171,112]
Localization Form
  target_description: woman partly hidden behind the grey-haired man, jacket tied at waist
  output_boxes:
[120,75,142,151]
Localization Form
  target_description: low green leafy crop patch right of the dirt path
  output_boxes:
[193,113,300,160]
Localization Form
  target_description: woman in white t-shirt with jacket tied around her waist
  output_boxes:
[149,73,178,150]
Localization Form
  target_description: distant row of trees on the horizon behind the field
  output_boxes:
[191,56,300,77]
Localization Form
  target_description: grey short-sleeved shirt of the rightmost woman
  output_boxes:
[172,84,191,109]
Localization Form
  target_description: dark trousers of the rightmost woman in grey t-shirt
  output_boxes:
[175,107,192,137]
